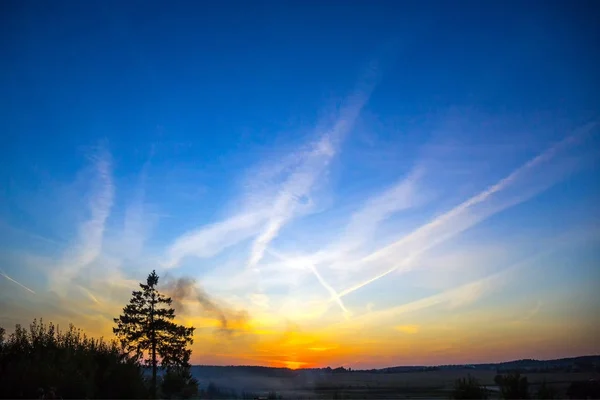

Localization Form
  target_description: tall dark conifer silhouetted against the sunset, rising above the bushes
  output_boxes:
[113,271,194,398]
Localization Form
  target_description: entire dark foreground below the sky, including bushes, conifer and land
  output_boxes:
[0,272,600,399]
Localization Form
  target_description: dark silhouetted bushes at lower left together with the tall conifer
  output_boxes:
[0,271,199,399]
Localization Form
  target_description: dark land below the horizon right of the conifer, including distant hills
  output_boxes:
[179,355,600,399]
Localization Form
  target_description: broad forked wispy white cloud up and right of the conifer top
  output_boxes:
[165,110,364,267]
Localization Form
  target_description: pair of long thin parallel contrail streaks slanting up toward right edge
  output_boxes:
[339,122,598,297]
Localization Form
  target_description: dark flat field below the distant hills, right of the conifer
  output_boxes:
[195,369,600,400]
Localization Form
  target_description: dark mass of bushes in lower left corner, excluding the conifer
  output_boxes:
[0,319,148,399]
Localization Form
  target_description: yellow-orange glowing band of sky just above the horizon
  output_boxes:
[2,264,599,368]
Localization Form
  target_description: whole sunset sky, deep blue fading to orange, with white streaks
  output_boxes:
[0,0,600,368]
